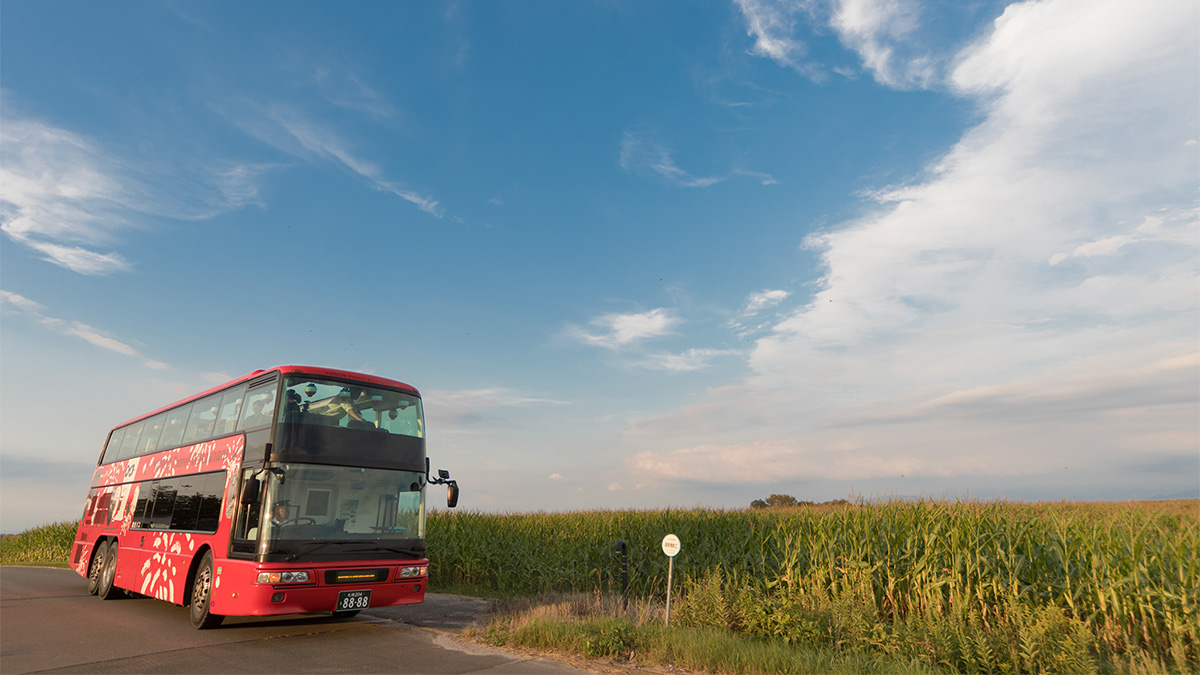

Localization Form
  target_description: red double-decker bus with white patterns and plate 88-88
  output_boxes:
[71,365,458,628]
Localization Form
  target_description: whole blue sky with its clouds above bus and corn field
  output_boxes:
[0,0,1200,531]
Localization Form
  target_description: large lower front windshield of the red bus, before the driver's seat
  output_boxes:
[260,464,425,552]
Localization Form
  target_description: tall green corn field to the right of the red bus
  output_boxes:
[427,500,1200,671]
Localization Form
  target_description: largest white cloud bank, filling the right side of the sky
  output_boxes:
[626,0,1200,491]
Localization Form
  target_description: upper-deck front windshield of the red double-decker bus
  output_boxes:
[278,376,425,438]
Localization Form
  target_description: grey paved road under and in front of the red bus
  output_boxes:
[0,567,586,674]
